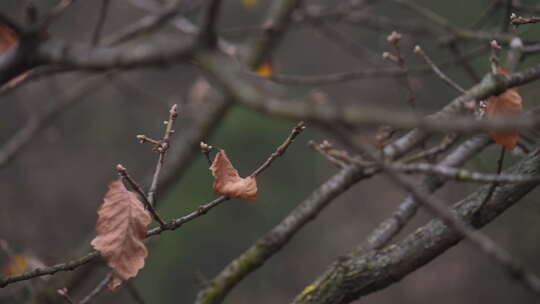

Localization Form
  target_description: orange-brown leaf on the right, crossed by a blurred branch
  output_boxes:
[486,68,523,150]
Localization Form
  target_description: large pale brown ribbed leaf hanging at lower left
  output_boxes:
[92,180,152,289]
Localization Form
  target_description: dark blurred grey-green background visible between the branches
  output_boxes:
[0,0,540,304]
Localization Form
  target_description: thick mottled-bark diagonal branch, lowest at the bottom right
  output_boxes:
[293,149,540,304]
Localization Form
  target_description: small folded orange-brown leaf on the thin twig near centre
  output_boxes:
[210,150,257,200]
